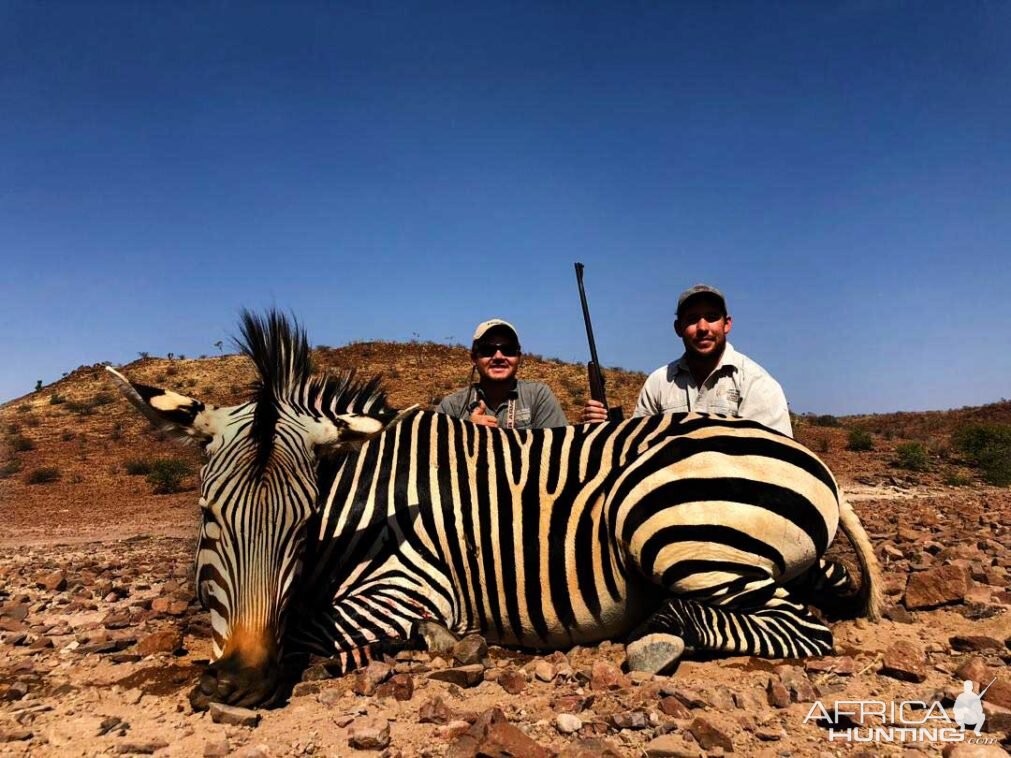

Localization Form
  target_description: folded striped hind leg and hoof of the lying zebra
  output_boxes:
[628,578,832,673]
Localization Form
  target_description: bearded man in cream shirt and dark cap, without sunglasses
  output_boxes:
[582,284,794,437]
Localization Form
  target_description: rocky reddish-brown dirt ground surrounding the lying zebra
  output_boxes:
[0,359,1011,756]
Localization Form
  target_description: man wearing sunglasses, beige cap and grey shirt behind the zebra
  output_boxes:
[439,318,568,429]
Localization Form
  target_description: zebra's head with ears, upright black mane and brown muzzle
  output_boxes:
[109,311,396,707]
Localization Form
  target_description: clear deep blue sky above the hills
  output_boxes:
[0,0,1011,413]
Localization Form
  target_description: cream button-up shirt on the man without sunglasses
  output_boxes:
[633,343,794,437]
